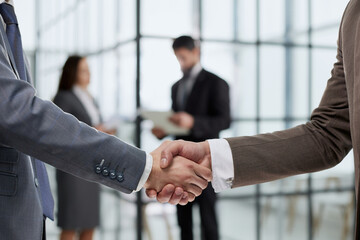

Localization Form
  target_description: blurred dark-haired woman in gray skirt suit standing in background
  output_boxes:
[54,56,114,240]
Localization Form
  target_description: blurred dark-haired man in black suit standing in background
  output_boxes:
[153,36,230,240]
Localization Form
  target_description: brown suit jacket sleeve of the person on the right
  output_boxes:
[227,26,352,187]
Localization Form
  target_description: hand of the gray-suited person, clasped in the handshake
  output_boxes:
[145,142,212,204]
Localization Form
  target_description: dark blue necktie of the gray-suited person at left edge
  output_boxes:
[0,3,54,220]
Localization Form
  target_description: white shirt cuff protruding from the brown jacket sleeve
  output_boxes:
[208,139,234,192]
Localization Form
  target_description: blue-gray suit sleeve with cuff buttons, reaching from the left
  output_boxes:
[0,72,146,193]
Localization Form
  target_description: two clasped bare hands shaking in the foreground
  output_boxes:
[144,140,212,205]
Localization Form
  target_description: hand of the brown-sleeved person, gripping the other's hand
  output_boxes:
[146,140,211,205]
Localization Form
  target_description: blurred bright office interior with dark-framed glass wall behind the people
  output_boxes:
[14,0,354,240]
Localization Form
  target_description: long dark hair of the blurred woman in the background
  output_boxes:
[58,55,84,91]
